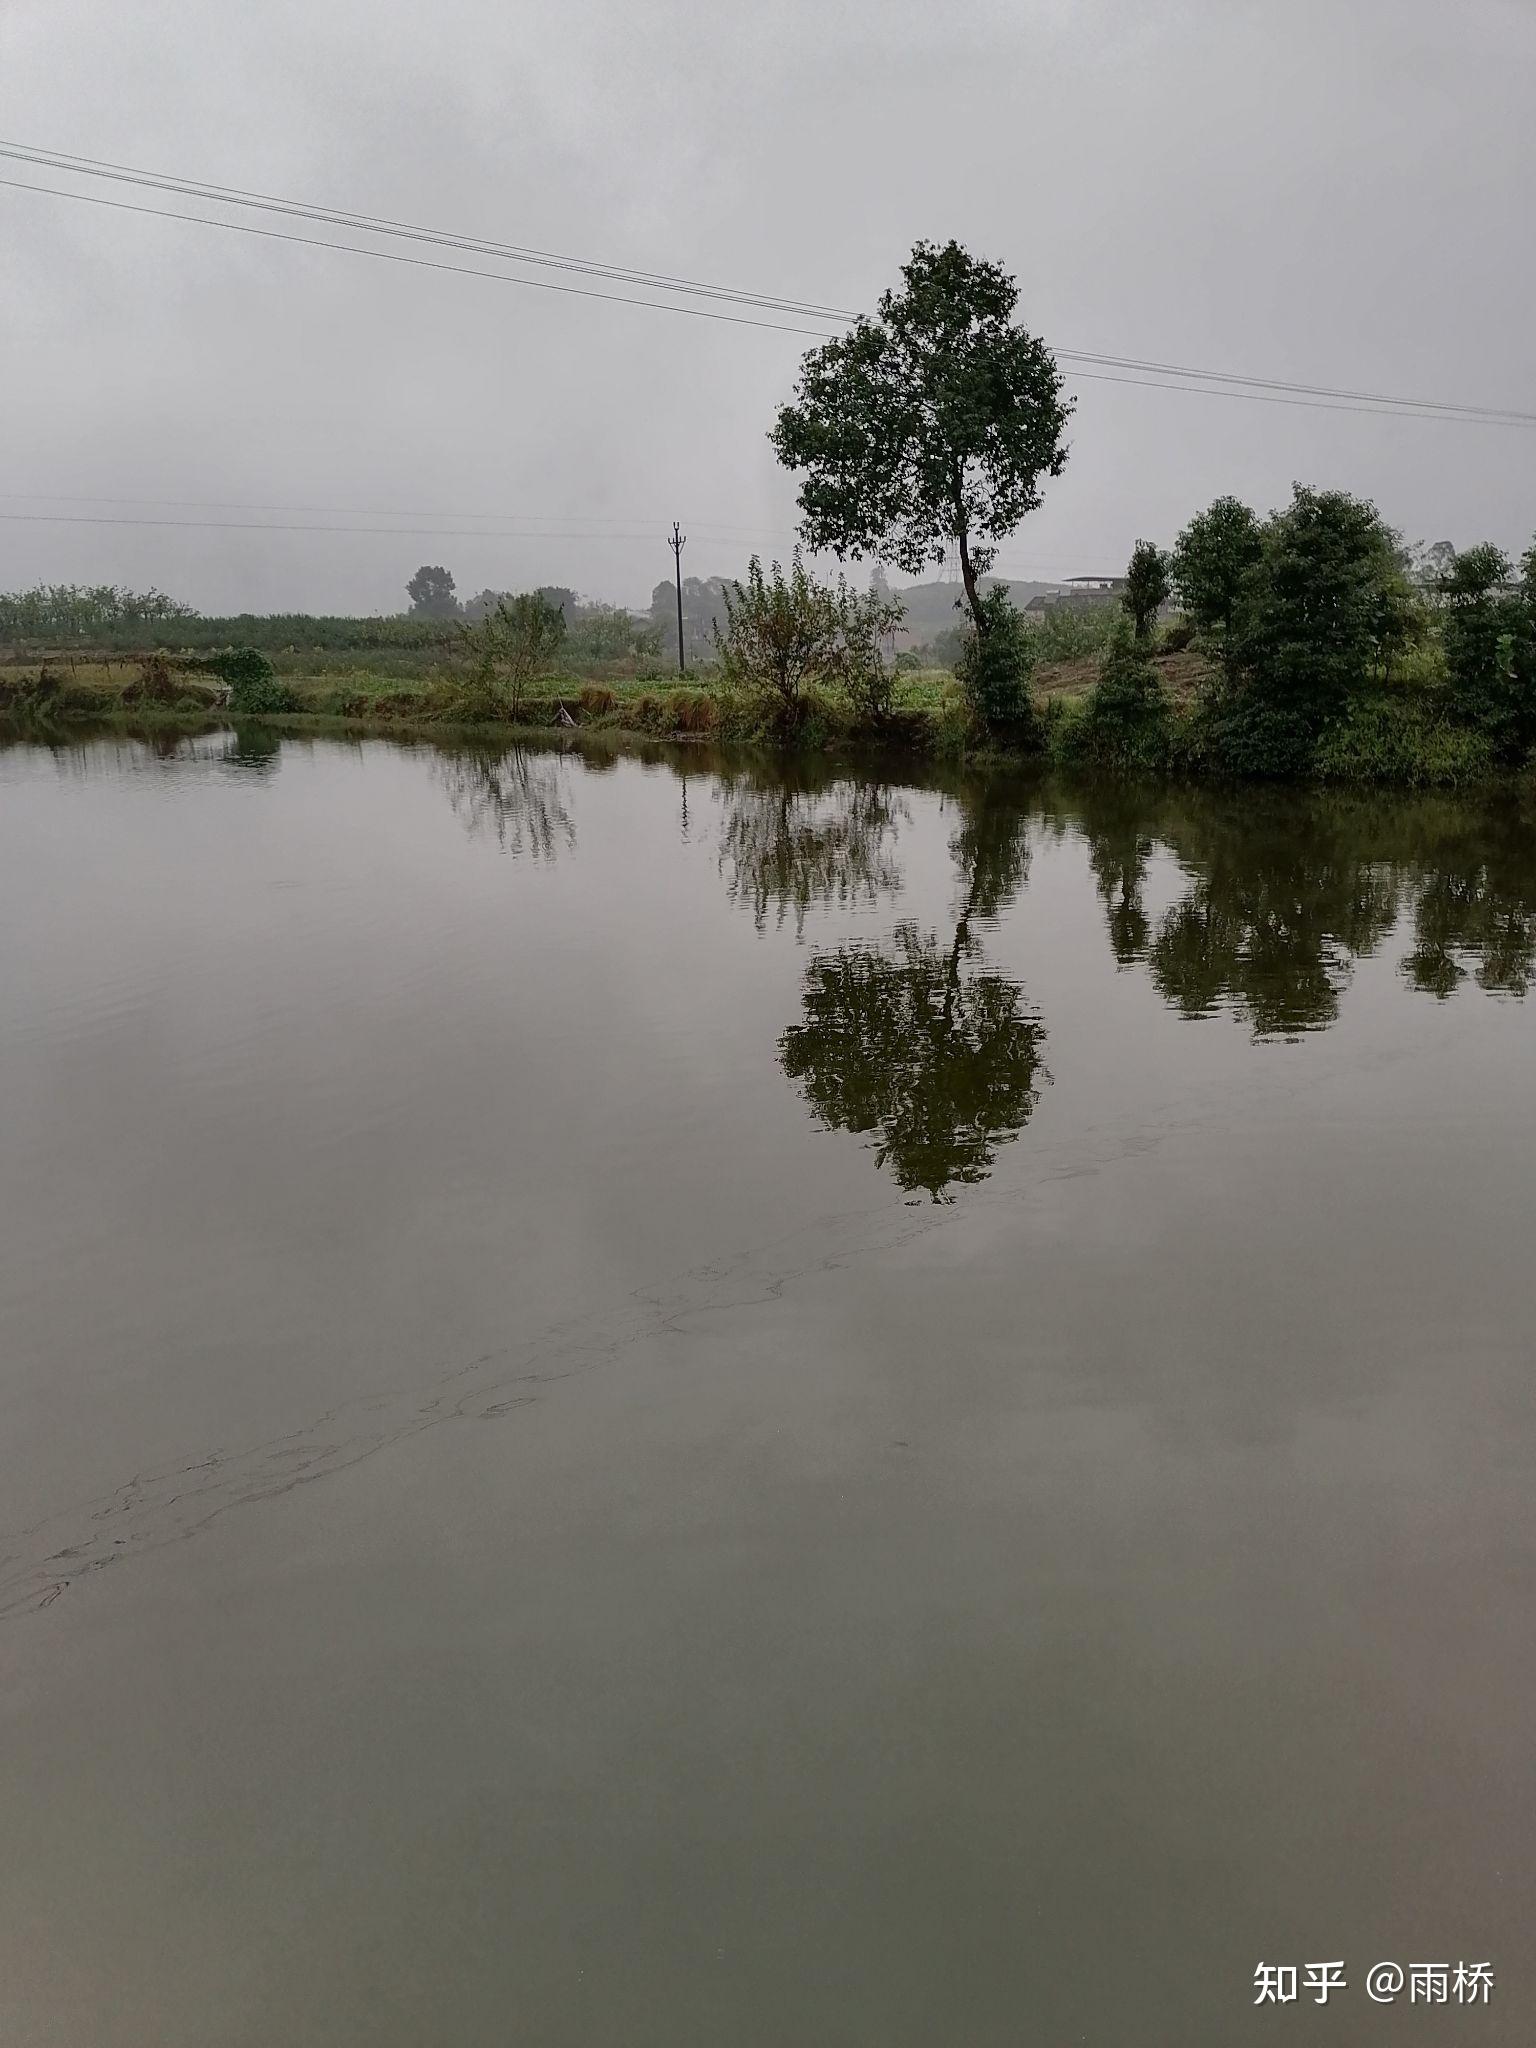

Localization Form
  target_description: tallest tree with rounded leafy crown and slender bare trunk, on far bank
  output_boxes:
[770,242,1071,637]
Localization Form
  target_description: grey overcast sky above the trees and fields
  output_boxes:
[0,0,1536,610]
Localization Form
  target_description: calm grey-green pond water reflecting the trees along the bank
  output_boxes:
[0,737,1536,2048]
